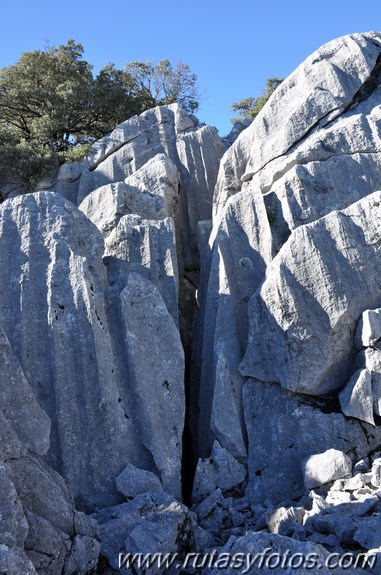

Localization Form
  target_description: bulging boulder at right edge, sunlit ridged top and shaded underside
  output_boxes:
[240,192,381,395]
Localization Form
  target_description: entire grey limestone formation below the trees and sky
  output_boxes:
[0,32,381,575]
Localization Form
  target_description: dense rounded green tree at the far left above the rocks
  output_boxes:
[0,40,93,152]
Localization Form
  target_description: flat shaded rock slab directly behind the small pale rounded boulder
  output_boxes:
[243,380,381,505]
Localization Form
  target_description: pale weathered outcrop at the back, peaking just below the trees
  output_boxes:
[52,104,223,267]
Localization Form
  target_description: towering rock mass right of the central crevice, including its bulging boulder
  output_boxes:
[195,29,381,483]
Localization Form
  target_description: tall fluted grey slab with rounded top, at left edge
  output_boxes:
[0,192,137,506]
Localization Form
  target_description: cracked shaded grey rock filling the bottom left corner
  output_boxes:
[0,403,100,575]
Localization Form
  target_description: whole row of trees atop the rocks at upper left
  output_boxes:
[0,40,200,196]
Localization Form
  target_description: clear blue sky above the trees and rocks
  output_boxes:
[0,0,381,135]
